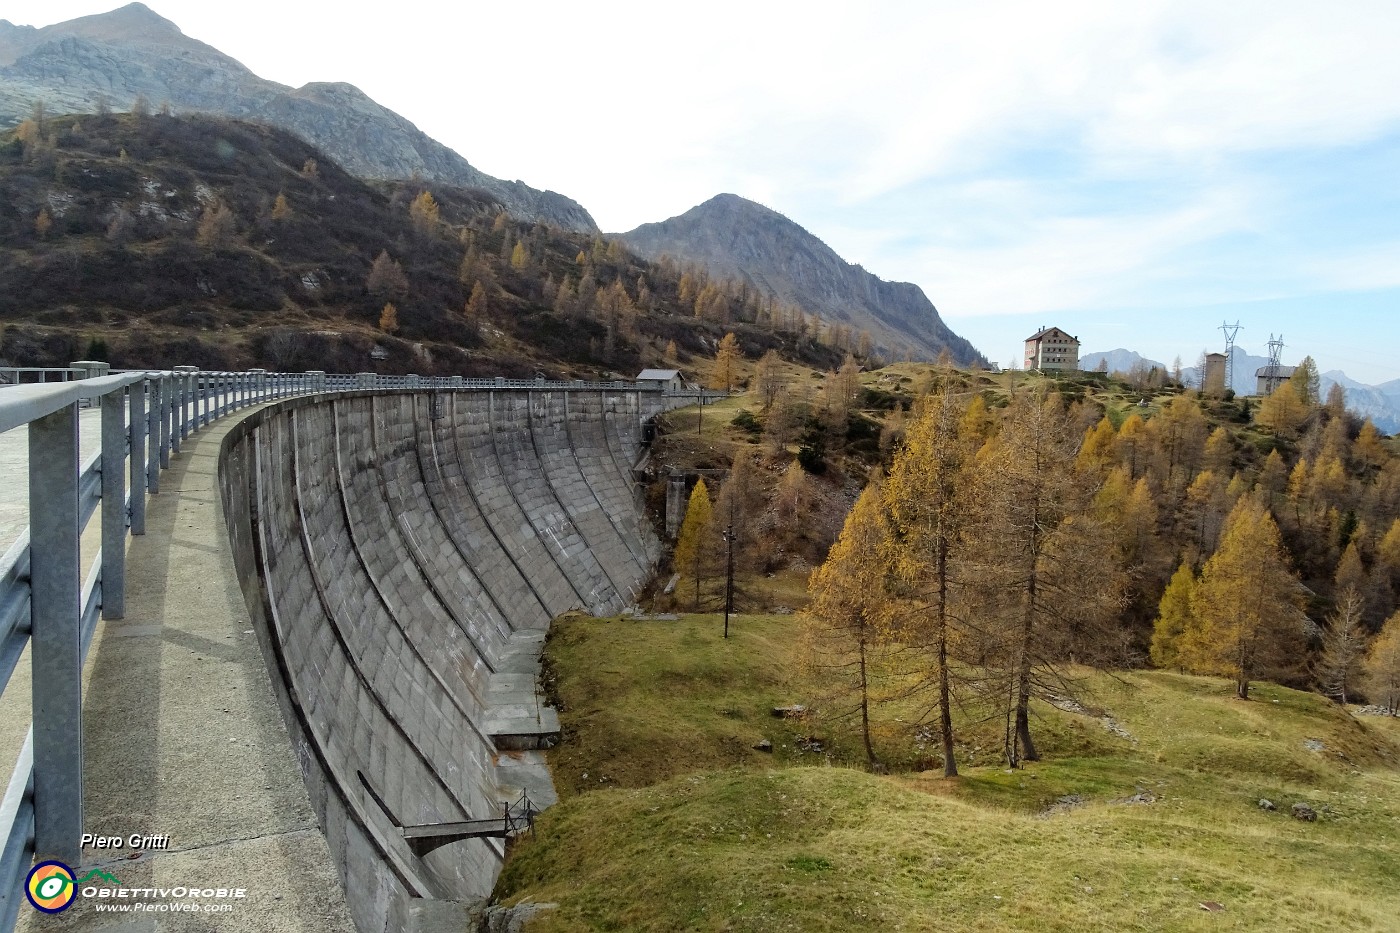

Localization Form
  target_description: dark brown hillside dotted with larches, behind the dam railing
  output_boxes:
[0,113,860,378]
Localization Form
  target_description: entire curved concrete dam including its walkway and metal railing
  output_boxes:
[0,371,685,932]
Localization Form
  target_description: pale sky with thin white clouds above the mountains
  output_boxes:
[8,0,1400,384]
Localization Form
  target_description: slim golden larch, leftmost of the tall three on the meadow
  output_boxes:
[804,485,889,768]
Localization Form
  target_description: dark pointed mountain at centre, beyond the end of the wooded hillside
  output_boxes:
[620,195,986,366]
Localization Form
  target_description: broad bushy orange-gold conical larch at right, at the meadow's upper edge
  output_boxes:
[1180,497,1306,699]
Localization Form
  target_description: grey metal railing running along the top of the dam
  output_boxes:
[0,364,662,930]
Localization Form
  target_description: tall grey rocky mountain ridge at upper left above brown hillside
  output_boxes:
[0,3,598,233]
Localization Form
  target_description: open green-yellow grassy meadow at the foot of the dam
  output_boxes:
[497,616,1400,932]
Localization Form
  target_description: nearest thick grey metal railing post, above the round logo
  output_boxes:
[29,405,83,866]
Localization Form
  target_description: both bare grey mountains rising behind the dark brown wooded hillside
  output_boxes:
[0,3,986,366]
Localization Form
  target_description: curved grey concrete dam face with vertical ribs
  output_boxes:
[220,389,666,932]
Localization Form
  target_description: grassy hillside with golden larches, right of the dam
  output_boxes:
[497,359,1400,932]
